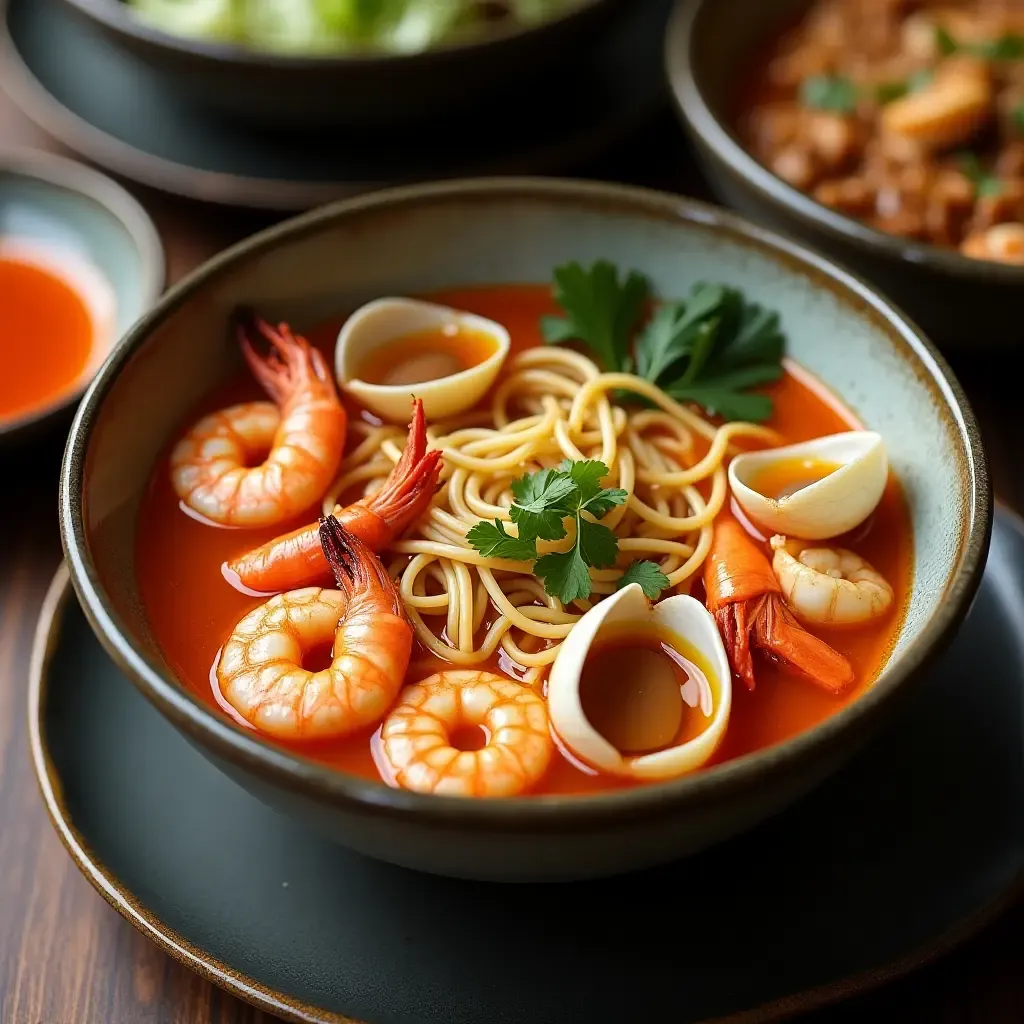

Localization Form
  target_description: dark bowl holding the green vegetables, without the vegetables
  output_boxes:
[65,0,630,130]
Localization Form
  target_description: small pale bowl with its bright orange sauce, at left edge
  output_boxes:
[0,151,164,445]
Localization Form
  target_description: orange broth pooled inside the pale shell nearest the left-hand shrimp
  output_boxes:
[355,324,496,387]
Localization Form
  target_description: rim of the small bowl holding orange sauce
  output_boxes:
[0,146,167,439]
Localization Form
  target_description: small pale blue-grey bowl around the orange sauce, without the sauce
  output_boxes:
[0,150,165,450]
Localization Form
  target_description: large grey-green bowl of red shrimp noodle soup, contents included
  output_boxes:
[60,179,992,881]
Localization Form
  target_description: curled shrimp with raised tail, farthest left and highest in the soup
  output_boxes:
[171,319,347,526]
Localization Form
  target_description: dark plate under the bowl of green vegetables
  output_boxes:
[0,0,669,210]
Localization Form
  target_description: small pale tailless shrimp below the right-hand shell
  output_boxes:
[771,537,893,626]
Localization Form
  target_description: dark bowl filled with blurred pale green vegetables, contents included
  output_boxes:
[58,0,629,130]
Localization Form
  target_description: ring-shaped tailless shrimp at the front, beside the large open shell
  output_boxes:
[381,671,554,797]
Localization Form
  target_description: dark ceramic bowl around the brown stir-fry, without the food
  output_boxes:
[666,0,1024,353]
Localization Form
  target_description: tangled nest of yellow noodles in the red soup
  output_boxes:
[324,347,777,686]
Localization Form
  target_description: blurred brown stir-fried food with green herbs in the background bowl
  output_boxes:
[738,0,1024,264]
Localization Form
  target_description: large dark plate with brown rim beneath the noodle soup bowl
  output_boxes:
[30,510,1024,1024]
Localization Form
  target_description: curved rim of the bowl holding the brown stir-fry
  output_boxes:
[664,0,1024,287]
